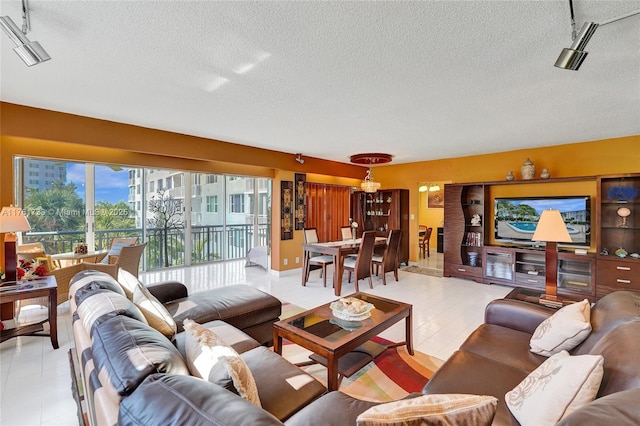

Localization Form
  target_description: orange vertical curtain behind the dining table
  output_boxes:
[305,182,351,241]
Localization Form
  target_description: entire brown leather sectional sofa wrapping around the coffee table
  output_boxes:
[72,272,640,426]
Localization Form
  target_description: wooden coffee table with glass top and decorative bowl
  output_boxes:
[273,293,413,391]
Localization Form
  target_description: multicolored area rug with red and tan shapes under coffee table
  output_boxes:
[281,303,443,402]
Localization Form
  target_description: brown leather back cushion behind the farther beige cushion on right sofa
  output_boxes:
[571,291,640,359]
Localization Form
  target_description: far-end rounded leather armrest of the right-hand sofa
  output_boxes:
[484,299,556,334]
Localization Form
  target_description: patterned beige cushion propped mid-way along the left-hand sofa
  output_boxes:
[183,319,261,407]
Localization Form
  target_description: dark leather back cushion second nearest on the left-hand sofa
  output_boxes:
[91,315,189,396]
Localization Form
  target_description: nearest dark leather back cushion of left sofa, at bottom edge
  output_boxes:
[118,374,282,426]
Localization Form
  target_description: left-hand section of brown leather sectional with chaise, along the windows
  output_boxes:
[70,271,326,426]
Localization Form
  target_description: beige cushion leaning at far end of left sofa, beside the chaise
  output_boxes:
[118,269,178,340]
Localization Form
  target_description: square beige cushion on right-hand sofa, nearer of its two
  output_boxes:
[505,351,604,426]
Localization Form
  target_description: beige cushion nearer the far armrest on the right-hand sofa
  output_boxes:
[530,299,591,356]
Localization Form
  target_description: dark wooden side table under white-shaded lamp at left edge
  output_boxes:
[0,276,59,349]
